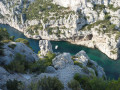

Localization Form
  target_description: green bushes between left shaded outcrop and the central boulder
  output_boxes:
[4,52,55,73]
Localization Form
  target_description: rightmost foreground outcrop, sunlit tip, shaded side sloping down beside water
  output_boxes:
[73,50,106,78]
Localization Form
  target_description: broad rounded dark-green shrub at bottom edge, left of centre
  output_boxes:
[29,77,64,90]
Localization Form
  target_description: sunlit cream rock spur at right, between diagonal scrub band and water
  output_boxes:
[69,26,120,60]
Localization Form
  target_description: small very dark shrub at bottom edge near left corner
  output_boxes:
[6,80,23,90]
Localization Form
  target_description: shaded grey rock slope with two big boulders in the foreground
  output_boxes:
[0,51,106,90]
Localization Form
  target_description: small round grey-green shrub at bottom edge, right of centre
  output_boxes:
[68,80,81,90]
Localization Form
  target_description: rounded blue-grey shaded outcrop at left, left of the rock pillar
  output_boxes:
[0,42,39,65]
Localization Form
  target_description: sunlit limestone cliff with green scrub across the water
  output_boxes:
[0,0,120,59]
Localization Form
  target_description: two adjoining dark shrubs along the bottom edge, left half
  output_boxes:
[6,76,64,90]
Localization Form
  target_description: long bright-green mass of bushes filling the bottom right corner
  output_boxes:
[74,73,120,90]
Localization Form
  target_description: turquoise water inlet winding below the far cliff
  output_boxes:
[0,24,120,79]
